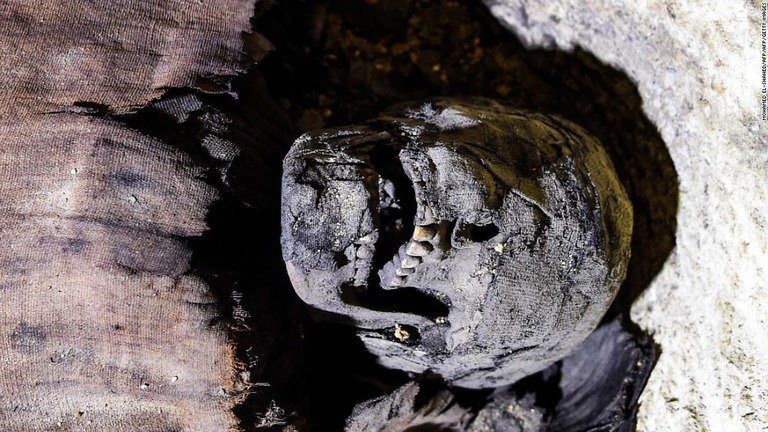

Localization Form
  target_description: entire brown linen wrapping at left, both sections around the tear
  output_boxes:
[0,0,264,432]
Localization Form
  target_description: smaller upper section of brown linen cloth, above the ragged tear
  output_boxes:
[0,0,254,119]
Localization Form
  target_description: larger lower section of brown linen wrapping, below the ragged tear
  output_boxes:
[0,114,240,431]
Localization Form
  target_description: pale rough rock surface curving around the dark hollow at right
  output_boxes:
[486,0,768,431]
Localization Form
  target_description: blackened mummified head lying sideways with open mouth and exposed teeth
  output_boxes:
[282,99,632,388]
